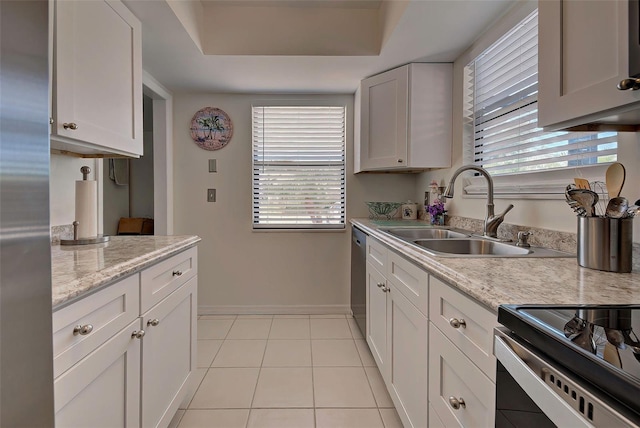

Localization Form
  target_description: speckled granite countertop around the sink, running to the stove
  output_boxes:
[351,219,640,312]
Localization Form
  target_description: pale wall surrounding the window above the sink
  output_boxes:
[414,1,640,242]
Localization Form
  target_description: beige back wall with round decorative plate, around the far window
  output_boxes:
[174,94,416,314]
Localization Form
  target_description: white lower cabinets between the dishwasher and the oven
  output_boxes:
[366,237,497,428]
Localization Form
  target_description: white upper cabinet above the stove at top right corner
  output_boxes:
[538,0,640,130]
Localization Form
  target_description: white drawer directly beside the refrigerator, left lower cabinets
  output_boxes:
[53,274,140,378]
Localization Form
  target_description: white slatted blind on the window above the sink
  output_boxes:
[465,11,617,176]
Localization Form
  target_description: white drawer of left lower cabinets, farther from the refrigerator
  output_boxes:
[140,247,198,313]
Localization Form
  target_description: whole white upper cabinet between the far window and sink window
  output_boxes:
[354,63,453,173]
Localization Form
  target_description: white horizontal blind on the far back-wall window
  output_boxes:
[252,106,345,229]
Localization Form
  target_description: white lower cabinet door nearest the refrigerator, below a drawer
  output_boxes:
[54,318,141,428]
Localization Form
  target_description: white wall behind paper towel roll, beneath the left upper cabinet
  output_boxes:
[49,154,96,226]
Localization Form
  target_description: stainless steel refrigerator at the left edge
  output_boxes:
[0,0,54,428]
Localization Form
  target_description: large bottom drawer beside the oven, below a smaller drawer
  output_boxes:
[429,324,496,427]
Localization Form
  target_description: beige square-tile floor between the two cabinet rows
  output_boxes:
[171,315,402,428]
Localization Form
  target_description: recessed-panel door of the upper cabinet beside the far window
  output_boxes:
[360,66,409,170]
